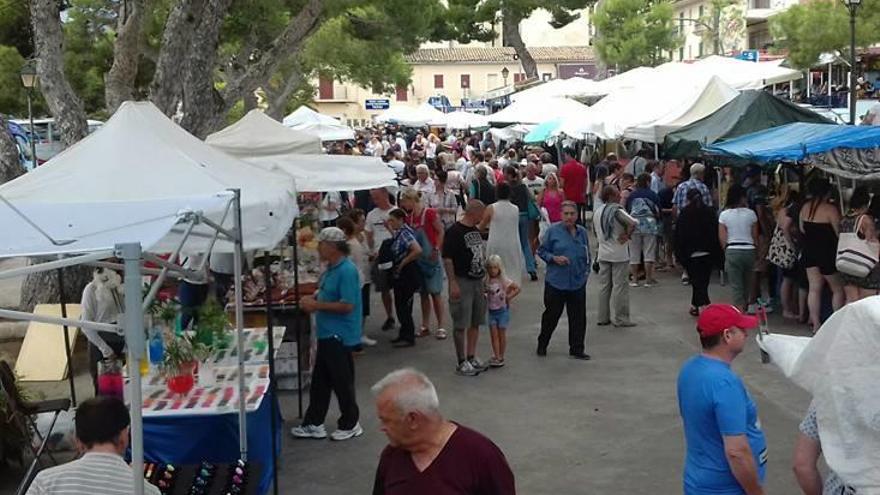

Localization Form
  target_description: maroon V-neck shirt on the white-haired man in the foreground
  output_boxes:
[373,425,516,495]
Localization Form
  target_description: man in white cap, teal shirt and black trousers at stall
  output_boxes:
[290,227,364,440]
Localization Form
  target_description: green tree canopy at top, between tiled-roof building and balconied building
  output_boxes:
[593,0,682,71]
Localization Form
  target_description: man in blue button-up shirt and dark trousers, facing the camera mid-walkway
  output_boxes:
[537,201,590,360]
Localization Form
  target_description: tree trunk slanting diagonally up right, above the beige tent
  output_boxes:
[223,0,324,117]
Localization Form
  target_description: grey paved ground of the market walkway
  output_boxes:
[0,268,808,495]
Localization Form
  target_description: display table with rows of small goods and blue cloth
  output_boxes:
[137,327,285,494]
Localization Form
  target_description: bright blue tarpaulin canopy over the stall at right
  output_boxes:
[703,122,880,162]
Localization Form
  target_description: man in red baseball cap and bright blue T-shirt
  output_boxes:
[678,304,767,495]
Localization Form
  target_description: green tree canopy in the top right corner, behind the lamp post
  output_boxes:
[770,0,880,69]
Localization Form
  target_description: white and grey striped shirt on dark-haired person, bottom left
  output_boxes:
[27,452,160,495]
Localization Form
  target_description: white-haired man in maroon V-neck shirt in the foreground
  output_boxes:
[372,368,516,495]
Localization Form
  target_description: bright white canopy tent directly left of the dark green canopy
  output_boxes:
[559,76,738,143]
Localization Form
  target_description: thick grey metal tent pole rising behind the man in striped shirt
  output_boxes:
[117,243,146,495]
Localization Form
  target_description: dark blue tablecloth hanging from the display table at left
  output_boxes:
[144,392,284,494]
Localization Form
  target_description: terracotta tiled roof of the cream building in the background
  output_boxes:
[406,46,594,64]
